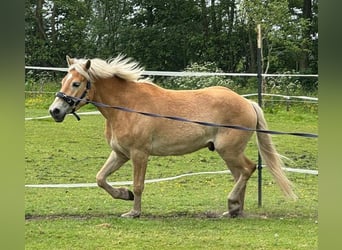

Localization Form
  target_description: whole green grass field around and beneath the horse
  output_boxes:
[25,103,318,250]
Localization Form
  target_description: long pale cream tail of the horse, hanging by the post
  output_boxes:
[251,102,297,200]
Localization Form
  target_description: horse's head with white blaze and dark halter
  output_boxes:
[49,56,91,122]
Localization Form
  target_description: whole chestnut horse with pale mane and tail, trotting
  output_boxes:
[49,55,296,218]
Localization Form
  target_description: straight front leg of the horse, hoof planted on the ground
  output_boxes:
[121,151,148,218]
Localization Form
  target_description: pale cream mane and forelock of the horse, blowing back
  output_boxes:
[68,55,144,81]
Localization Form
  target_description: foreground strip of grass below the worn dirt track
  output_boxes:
[26,216,317,250]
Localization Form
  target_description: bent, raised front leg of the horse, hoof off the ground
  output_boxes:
[96,151,134,200]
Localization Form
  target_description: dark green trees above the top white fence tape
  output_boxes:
[25,0,318,78]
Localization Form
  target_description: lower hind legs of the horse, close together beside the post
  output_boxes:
[223,154,255,217]
